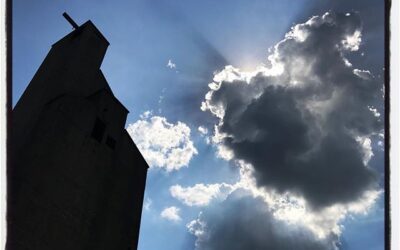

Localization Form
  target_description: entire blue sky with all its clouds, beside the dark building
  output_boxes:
[12,0,384,250]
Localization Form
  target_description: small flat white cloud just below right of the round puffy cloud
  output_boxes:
[169,183,234,206]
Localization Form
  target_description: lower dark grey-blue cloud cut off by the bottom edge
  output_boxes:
[188,190,337,250]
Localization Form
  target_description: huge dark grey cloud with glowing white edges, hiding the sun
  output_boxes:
[206,13,383,208]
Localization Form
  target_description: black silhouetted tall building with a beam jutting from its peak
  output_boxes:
[7,13,148,250]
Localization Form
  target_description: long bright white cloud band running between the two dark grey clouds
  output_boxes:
[182,161,382,240]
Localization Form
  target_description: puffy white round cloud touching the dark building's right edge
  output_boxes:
[127,111,197,172]
